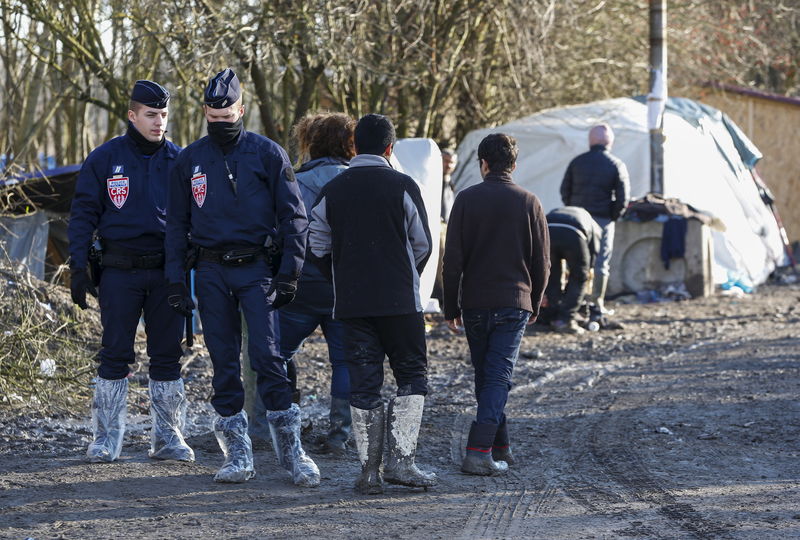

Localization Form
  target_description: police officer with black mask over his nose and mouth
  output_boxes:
[166,69,319,486]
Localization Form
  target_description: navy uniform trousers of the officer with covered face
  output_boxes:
[195,259,292,416]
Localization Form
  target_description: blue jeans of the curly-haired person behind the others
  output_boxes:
[278,306,350,400]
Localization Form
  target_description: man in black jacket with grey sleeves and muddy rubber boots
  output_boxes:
[309,114,437,494]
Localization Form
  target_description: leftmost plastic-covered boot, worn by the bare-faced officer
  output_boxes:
[86,377,128,463]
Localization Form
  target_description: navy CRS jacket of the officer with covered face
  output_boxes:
[165,131,308,283]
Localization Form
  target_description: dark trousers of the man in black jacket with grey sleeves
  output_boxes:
[342,313,428,410]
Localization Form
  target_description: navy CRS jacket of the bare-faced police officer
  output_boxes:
[67,135,181,268]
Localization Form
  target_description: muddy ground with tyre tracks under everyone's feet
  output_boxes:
[0,285,800,539]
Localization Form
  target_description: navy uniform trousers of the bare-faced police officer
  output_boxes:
[98,268,184,381]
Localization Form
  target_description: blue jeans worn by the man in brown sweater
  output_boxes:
[461,308,531,424]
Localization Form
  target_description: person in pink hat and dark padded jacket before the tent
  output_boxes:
[561,124,630,313]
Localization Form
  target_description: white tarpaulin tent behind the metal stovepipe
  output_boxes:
[453,98,784,284]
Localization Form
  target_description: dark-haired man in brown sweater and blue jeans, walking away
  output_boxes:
[443,133,550,475]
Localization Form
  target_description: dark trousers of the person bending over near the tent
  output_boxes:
[545,227,591,322]
